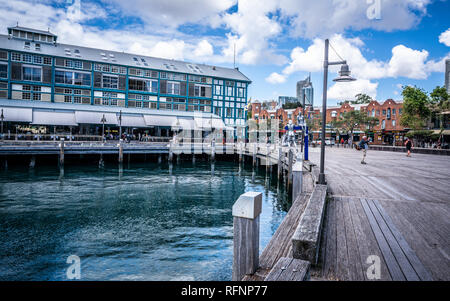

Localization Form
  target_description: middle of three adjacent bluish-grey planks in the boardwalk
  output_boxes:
[367,200,420,281]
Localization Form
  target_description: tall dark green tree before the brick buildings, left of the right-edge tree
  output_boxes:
[400,86,431,130]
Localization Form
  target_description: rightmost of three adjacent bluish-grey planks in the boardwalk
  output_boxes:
[373,200,433,281]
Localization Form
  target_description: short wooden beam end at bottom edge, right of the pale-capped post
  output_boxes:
[265,257,310,281]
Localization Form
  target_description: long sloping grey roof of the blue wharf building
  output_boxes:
[0,35,251,83]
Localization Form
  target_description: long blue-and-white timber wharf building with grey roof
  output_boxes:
[0,26,251,138]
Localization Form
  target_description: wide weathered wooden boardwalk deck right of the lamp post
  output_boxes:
[310,148,450,281]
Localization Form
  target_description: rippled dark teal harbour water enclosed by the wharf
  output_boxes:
[0,161,289,281]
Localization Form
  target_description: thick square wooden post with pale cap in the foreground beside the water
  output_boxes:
[232,191,262,281]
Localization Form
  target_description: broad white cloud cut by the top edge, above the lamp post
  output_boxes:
[279,0,431,38]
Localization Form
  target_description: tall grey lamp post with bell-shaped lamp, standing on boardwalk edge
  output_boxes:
[318,39,356,185]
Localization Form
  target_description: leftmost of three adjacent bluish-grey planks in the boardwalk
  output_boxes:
[360,199,406,281]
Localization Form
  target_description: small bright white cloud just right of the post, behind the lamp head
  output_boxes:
[328,79,378,100]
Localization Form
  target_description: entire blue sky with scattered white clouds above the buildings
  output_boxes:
[0,0,450,104]
